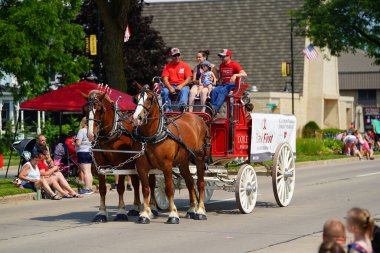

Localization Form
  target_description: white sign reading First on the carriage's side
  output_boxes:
[250,113,297,162]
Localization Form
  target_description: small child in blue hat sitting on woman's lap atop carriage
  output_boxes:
[189,61,216,112]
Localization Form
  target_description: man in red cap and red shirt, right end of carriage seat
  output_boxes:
[211,49,247,112]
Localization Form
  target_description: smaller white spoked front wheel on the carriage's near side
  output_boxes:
[235,164,258,213]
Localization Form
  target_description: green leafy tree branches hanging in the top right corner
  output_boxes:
[291,0,380,65]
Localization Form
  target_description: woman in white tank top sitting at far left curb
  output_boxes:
[18,152,61,200]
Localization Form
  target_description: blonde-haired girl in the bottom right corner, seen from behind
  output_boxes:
[347,207,375,253]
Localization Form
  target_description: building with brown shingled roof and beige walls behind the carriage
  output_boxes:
[144,0,354,132]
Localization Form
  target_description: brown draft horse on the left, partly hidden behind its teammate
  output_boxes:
[82,90,158,222]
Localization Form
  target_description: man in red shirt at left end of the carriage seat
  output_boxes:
[161,48,192,111]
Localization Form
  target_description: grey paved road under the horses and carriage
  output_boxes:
[0,160,380,253]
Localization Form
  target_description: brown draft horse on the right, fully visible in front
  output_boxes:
[133,86,210,224]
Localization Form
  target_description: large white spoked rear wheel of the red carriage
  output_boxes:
[272,143,296,207]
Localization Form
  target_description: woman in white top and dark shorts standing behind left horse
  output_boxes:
[75,117,94,194]
